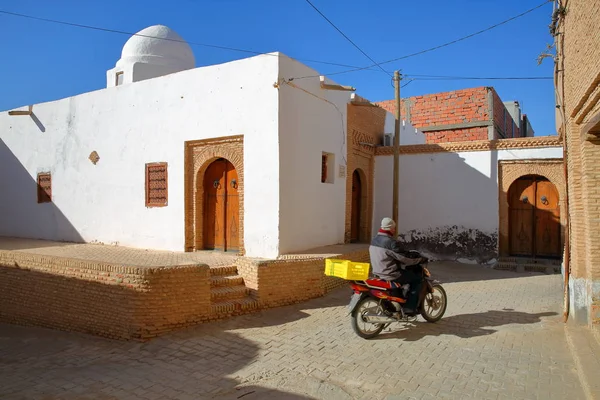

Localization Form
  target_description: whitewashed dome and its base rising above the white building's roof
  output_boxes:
[106,25,196,87]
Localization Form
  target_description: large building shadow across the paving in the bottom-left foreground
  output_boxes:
[0,324,312,400]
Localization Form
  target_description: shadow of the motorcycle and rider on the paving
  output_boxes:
[376,309,558,342]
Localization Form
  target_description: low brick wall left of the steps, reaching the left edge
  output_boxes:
[0,251,210,340]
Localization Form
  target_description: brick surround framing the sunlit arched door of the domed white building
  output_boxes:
[184,135,245,255]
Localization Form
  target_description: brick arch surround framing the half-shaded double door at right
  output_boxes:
[498,159,567,257]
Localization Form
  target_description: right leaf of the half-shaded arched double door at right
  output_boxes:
[534,181,561,257]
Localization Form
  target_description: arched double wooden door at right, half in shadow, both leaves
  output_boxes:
[508,176,562,258]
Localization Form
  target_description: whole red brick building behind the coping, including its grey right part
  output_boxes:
[377,86,533,143]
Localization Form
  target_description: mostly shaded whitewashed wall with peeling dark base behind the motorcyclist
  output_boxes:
[373,148,562,260]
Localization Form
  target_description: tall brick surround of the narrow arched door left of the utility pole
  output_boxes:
[344,104,386,243]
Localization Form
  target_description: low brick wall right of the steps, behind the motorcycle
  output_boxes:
[238,249,369,308]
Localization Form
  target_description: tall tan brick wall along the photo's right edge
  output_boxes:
[555,0,600,325]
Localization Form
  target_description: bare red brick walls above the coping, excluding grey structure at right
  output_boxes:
[377,86,518,143]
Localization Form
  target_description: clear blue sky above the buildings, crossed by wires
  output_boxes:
[0,0,555,135]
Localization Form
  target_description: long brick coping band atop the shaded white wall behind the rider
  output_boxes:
[375,136,562,156]
